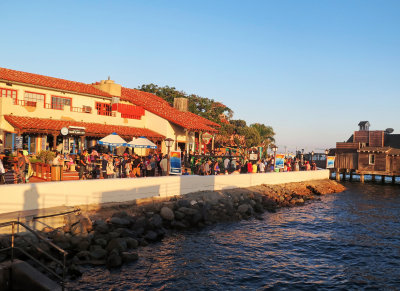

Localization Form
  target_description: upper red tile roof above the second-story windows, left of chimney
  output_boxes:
[0,68,112,97]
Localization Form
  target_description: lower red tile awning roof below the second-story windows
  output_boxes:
[4,115,165,139]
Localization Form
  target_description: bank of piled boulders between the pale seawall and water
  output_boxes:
[0,180,345,278]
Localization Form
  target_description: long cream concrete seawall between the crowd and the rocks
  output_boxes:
[0,170,329,214]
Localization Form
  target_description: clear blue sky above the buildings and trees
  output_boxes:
[0,0,400,151]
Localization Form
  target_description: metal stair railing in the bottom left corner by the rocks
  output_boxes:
[0,221,68,291]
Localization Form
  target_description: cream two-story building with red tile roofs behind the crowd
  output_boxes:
[0,68,219,153]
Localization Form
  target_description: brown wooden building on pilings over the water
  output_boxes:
[331,121,400,183]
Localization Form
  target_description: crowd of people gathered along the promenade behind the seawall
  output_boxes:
[0,148,317,184]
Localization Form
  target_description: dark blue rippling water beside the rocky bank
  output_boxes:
[70,183,400,290]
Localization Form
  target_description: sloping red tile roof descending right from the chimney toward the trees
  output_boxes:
[121,87,219,133]
